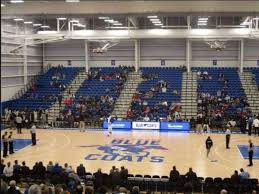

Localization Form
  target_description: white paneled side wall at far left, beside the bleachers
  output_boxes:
[1,20,43,101]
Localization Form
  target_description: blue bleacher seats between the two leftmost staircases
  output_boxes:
[64,67,134,120]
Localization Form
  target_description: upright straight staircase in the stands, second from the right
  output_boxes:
[181,72,197,119]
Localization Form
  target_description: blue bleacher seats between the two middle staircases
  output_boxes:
[131,67,182,120]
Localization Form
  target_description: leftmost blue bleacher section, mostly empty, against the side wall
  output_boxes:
[2,67,81,110]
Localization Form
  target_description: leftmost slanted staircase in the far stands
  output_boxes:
[48,70,87,124]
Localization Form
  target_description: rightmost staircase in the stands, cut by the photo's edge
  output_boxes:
[239,72,259,114]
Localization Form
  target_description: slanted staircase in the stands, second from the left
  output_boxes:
[112,72,142,119]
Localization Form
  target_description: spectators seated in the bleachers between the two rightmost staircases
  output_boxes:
[197,71,253,132]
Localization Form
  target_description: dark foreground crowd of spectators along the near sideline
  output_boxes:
[0,160,259,194]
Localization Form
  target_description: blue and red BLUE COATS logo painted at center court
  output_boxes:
[80,139,168,163]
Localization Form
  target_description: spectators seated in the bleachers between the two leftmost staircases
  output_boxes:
[56,66,134,128]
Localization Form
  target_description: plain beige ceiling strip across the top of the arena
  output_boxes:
[1,0,259,15]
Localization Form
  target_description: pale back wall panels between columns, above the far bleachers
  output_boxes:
[45,39,259,67]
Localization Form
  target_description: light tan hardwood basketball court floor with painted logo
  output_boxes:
[2,129,259,178]
